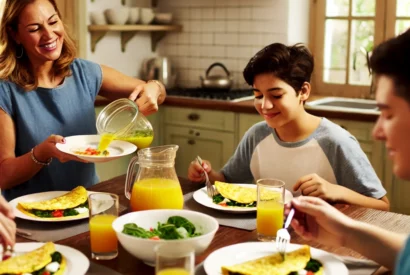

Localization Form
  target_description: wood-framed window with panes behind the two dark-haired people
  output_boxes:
[310,0,410,97]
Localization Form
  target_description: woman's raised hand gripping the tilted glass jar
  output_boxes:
[128,81,163,116]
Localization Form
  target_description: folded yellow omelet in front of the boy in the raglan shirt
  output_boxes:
[215,181,280,204]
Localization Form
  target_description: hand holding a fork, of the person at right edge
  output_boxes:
[285,196,355,249]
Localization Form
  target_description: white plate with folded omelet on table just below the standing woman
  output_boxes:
[10,186,100,222]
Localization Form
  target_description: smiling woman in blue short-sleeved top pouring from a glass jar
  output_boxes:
[0,0,166,200]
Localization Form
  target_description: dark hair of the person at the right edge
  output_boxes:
[370,29,410,104]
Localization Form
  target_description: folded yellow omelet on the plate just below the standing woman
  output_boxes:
[18,186,87,211]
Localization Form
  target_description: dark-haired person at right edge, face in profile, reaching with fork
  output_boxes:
[292,30,410,275]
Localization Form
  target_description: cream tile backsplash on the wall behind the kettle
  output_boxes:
[157,0,292,88]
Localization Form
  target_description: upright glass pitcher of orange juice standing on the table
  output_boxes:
[125,145,184,211]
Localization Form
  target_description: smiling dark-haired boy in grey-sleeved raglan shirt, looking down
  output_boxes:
[188,43,389,210]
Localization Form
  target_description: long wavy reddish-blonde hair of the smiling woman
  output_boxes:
[0,0,76,91]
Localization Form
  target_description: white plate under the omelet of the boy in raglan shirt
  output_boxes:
[193,183,293,213]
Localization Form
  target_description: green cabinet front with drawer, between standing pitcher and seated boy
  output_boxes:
[162,106,236,176]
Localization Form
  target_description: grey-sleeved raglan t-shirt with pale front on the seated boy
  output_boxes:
[221,118,386,199]
